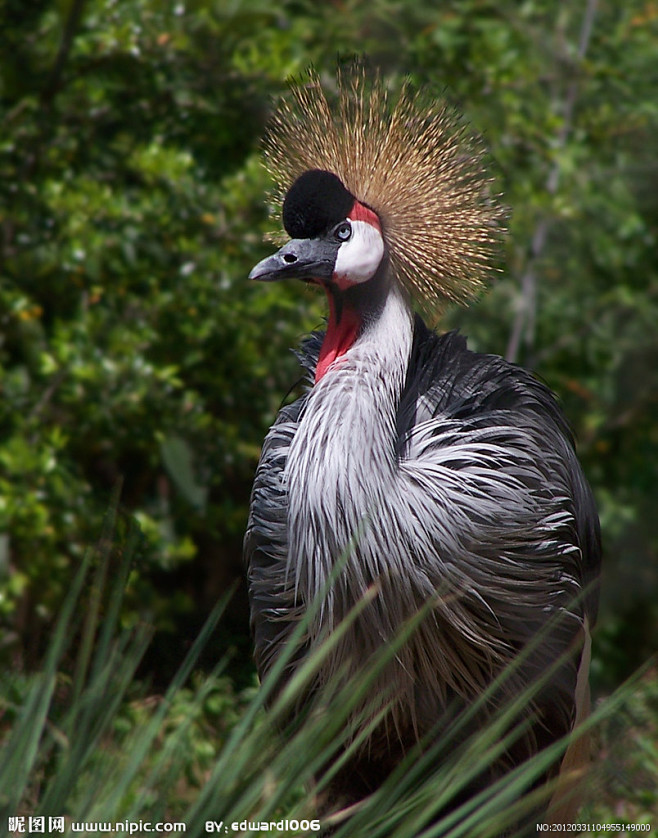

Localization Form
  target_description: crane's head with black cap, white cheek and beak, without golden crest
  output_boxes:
[249,169,385,290]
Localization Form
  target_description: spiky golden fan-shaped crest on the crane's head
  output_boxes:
[265,64,504,310]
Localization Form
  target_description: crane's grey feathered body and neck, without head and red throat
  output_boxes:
[245,293,600,802]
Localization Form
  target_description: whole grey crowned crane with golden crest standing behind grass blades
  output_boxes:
[245,69,600,832]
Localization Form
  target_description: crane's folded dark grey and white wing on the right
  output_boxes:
[397,319,600,742]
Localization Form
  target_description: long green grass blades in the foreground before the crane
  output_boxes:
[0,502,652,838]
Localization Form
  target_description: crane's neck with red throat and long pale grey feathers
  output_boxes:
[285,284,413,611]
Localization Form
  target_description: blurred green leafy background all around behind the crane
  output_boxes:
[0,0,658,812]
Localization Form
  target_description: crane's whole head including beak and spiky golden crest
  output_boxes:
[246,64,504,310]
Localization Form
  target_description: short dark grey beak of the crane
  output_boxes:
[249,239,340,282]
